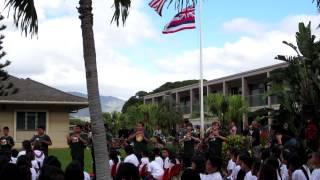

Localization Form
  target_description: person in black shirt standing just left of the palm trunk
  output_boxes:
[67,125,88,167]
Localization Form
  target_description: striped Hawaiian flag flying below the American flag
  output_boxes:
[162,6,196,34]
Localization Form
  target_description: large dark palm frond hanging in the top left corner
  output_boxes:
[5,0,38,37]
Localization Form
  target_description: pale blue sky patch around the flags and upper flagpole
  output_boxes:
[117,0,317,72]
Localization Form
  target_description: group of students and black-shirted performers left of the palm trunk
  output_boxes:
[0,126,91,180]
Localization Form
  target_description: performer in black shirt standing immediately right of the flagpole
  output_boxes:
[205,121,226,157]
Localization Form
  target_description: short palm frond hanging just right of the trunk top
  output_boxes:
[111,0,131,26]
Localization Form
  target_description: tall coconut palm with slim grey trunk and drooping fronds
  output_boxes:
[6,0,131,177]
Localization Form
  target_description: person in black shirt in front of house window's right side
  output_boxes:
[30,126,52,156]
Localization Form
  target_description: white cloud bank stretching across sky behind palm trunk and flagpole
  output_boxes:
[4,0,320,98]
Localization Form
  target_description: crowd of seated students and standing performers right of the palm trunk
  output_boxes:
[109,121,320,180]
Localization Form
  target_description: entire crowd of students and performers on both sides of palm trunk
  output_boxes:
[0,118,320,180]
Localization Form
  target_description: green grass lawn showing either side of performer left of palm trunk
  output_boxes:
[49,148,92,173]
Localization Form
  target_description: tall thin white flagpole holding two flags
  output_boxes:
[199,0,204,138]
